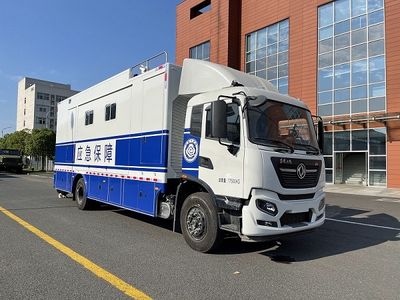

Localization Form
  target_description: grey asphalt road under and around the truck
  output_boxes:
[0,173,400,299]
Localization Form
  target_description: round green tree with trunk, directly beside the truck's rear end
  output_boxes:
[25,128,56,170]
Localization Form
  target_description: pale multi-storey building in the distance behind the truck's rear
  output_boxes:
[16,77,78,131]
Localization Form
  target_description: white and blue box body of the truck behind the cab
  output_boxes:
[54,64,184,216]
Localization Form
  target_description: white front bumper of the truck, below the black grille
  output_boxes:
[241,189,325,238]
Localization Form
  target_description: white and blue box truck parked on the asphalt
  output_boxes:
[54,52,325,252]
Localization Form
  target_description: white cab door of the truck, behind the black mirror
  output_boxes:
[199,100,245,198]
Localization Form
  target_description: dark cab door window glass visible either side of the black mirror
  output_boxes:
[206,103,240,144]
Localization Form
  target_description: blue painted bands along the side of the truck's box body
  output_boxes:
[54,130,169,216]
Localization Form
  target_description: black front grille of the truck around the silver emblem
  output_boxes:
[271,157,321,189]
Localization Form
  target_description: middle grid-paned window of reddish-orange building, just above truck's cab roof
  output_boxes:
[245,20,289,94]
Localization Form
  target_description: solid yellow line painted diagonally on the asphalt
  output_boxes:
[0,206,151,299]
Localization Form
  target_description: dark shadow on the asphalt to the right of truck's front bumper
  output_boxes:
[214,205,400,264]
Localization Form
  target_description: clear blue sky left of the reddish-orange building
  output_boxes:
[0,0,182,134]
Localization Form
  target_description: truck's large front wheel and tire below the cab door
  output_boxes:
[180,193,222,253]
